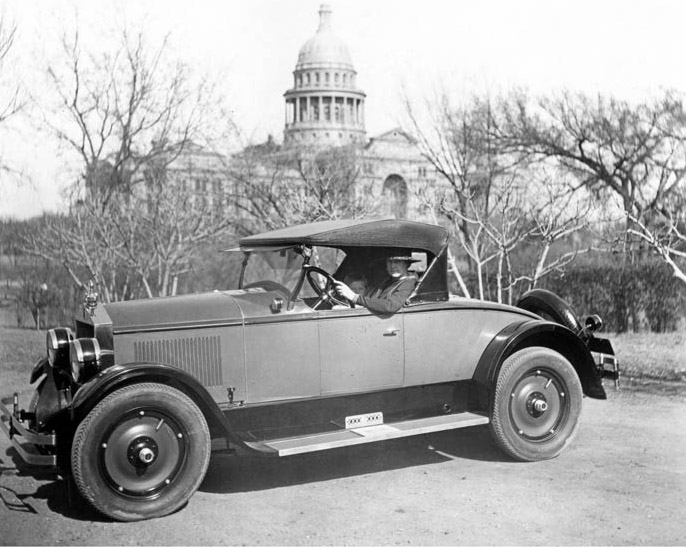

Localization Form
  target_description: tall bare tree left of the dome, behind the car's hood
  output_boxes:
[25,23,238,301]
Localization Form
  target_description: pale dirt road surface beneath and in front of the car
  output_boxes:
[0,391,686,545]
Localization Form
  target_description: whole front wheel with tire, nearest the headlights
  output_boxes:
[71,383,211,521]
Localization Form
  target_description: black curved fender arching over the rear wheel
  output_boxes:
[472,320,607,409]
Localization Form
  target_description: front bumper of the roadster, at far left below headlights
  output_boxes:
[0,393,57,467]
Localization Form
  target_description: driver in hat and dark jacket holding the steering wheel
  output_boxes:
[336,255,416,314]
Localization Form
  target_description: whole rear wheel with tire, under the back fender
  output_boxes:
[491,347,582,461]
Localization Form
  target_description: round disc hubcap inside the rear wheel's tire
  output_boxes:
[509,369,569,441]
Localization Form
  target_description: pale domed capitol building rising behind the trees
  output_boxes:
[169,4,435,220]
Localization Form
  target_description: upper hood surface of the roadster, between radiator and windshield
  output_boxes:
[104,289,286,334]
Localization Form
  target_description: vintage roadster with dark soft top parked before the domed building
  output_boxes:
[0,219,619,521]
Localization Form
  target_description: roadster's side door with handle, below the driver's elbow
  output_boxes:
[318,308,405,395]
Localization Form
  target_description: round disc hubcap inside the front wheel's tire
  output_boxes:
[100,410,188,498]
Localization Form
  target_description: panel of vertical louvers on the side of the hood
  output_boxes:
[133,336,223,386]
